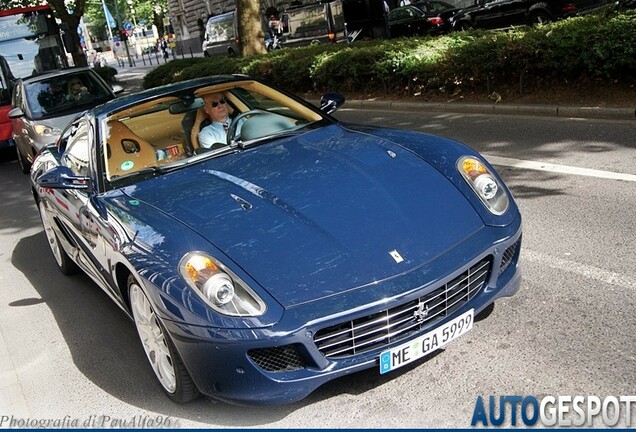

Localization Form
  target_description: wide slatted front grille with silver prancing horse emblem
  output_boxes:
[314,256,492,358]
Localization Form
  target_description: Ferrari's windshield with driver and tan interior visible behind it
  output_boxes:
[101,80,326,181]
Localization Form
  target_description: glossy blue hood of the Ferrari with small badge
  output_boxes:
[126,125,483,307]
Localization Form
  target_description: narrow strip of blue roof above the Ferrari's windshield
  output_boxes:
[92,75,251,117]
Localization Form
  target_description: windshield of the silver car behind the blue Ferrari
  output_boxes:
[24,71,112,120]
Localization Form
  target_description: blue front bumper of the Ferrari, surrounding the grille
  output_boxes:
[159,218,521,405]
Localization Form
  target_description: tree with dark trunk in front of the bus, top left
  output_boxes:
[0,0,87,66]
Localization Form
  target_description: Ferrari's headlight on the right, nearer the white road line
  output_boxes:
[457,156,509,215]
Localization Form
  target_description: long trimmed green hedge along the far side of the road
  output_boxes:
[144,11,636,94]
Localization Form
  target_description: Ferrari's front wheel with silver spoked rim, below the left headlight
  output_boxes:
[128,275,199,404]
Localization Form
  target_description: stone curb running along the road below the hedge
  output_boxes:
[340,100,636,120]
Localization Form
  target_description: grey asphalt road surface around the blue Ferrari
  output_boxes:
[0,110,636,428]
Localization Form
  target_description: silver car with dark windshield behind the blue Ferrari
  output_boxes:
[9,68,123,174]
